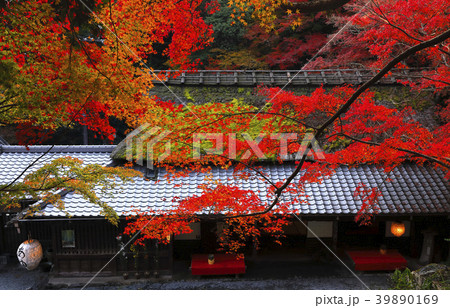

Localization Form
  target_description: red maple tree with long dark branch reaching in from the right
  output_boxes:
[123,1,450,252]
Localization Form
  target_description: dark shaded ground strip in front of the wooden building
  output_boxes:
[0,254,391,290]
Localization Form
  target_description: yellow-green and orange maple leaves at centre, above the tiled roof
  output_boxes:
[112,97,288,165]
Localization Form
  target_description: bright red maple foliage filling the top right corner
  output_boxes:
[309,0,449,90]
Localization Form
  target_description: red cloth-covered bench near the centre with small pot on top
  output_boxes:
[191,254,245,275]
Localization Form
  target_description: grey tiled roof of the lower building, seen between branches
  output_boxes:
[0,146,450,217]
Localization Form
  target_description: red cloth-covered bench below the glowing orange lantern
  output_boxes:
[347,250,408,271]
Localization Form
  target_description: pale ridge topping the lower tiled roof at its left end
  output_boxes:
[0,145,116,153]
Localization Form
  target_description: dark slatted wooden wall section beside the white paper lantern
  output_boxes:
[2,219,173,277]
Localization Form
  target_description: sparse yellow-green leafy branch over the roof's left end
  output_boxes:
[0,157,140,225]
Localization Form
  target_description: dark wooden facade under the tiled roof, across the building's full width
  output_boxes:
[0,215,450,277]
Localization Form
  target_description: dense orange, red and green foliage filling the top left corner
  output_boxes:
[0,0,212,144]
